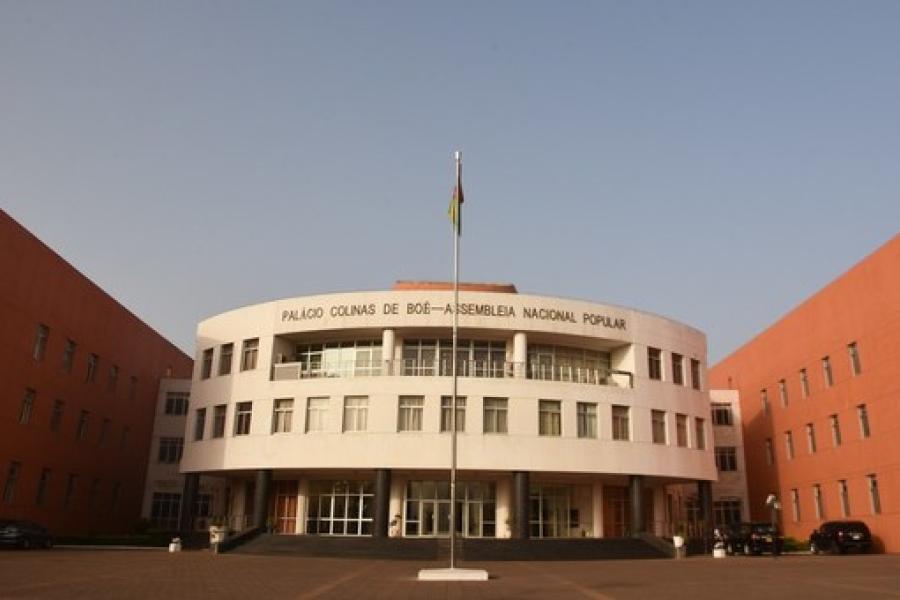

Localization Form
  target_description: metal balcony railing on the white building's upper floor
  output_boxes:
[272,359,634,388]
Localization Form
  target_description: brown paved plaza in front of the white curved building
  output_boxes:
[0,549,900,600]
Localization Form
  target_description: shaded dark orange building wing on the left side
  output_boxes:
[0,211,192,536]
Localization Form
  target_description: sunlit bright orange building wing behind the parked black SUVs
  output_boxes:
[709,236,900,552]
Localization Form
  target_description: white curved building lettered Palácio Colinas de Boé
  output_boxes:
[181,282,716,538]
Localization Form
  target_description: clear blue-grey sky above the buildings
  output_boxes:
[0,0,900,361]
